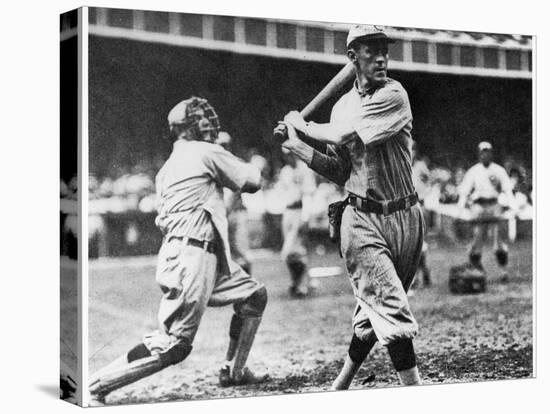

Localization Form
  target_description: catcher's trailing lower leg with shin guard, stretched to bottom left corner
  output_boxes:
[89,341,192,399]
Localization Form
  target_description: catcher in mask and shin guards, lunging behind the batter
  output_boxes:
[89,97,267,403]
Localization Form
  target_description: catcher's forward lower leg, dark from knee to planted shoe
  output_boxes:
[219,286,267,387]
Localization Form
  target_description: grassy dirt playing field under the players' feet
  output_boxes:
[89,238,533,404]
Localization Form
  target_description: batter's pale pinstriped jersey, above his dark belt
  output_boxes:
[331,78,414,200]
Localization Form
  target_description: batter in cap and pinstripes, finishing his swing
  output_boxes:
[283,25,425,389]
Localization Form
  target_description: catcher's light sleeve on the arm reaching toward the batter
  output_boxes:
[205,146,261,191]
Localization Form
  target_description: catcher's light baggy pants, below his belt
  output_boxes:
[143,237,263,351]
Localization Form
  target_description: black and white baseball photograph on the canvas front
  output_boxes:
[71,7,536,406]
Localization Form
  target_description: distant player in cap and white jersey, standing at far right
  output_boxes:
[458,141,514,282]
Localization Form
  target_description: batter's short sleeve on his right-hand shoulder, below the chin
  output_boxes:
[353,85,412,145]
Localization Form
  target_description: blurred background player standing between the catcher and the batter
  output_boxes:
[279,154,317,298]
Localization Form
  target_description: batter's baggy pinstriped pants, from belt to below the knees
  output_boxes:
[341,205,425,345]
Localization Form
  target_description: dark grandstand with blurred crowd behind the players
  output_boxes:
[61,25,533,255]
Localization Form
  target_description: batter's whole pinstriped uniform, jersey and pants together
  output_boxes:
[331,79,425,345]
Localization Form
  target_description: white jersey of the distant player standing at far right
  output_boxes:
[459,162,512,201]
